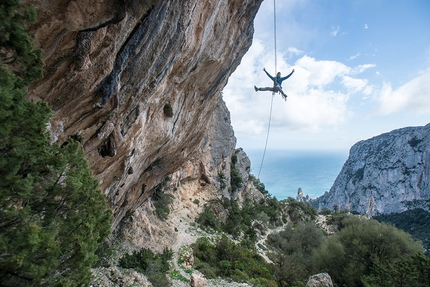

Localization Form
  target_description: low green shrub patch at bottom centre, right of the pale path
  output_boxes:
[192,236,276,286]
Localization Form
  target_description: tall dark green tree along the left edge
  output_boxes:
[0,0,112,286]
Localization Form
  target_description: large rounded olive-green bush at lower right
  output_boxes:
[313,216,423,286]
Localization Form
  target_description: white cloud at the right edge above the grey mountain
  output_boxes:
[377,69,430,115]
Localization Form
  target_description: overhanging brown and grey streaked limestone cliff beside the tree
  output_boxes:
[25,0,262,228]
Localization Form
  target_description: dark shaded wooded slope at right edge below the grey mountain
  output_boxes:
[373,208,430,250]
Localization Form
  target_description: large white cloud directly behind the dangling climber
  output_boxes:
[223,43,372,145]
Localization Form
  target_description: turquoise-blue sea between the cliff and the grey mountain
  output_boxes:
[245,150,348,200]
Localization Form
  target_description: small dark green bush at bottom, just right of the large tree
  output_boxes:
[119,248,173,287]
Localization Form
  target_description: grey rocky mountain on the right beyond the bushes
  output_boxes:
[313,124,430,216]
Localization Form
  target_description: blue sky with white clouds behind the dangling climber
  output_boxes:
[223,0,430,156]
